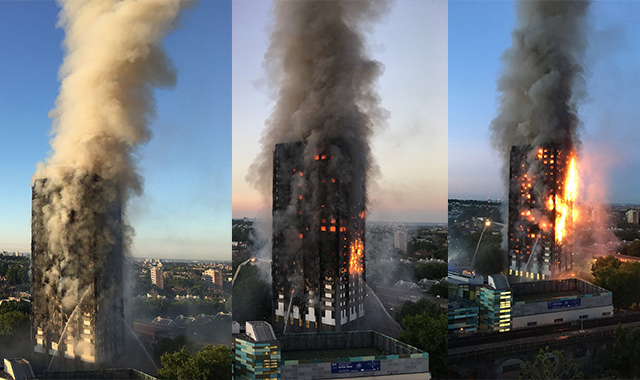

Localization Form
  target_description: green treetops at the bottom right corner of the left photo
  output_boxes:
[158,345,232,380]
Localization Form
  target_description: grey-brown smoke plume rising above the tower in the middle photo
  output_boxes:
[247,0,388,264]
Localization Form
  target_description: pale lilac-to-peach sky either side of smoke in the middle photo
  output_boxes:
[232,0,447,222]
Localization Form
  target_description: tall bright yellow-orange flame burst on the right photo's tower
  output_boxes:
[547,155,578,244]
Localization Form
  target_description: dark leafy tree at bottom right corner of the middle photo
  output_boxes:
[396,299,448,379]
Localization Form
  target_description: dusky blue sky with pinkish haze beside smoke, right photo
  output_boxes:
[448,1,640,203]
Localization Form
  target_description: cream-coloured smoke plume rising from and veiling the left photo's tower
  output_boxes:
[32,0,185,362]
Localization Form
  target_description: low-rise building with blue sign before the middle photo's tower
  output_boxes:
[233,321,430,380]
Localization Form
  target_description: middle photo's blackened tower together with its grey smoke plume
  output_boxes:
[247,1,389,332]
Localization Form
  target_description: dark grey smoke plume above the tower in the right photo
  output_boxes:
[491,1,589,163]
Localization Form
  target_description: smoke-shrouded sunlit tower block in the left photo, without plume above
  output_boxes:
[31,175,124,365]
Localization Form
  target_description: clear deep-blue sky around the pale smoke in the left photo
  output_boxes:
[0,1,231,260]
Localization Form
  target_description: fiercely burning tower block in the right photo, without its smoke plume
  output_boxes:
[507,144,574,282]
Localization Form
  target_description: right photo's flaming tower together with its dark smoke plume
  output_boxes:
[491,1,589,279]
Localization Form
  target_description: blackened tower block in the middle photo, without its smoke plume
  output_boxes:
[272,142,365,333]
